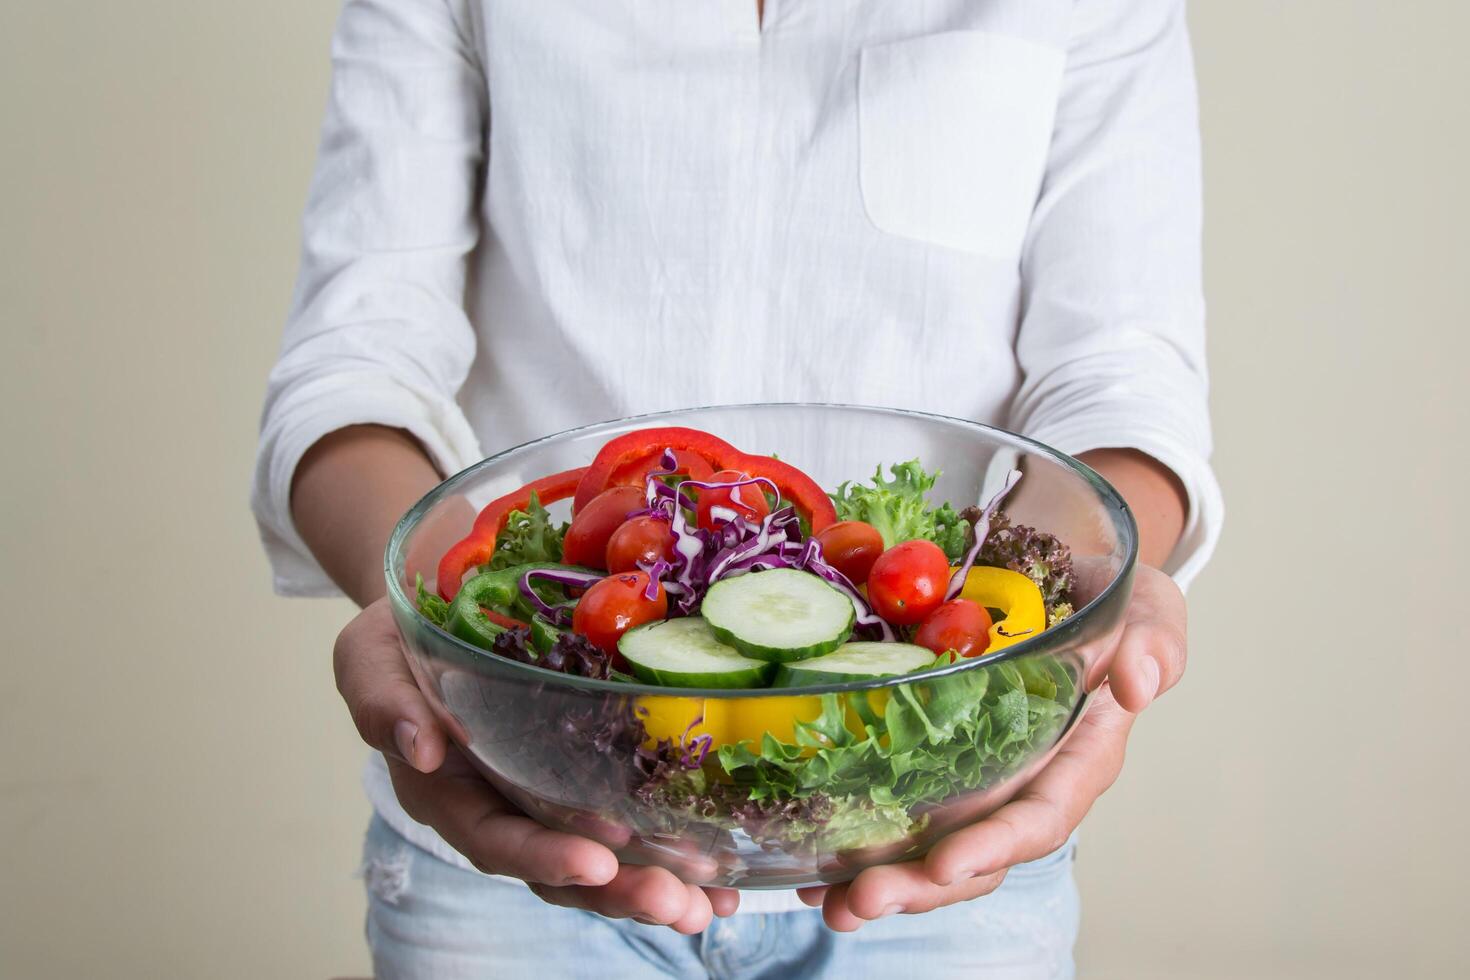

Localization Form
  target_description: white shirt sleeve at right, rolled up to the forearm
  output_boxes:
[1010,0,1225,588]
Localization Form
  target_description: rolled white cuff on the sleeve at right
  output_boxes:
[1026,407,1225,591]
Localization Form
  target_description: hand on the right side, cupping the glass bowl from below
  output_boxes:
[801,564,1186,932]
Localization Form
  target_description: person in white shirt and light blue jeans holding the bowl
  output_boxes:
[253,0,1220,977]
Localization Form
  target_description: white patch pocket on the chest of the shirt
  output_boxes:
[858,31,1064,259]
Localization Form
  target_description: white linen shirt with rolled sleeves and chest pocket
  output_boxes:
[251,0,1222,911]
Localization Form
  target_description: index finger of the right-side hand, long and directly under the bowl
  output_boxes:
[923,691,1133,886]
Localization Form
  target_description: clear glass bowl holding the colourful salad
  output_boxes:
[387,404,1136,889]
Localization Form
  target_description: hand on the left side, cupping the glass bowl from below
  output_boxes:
[332,599,739,934]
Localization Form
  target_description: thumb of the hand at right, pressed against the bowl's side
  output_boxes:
[1108,567,1188,714]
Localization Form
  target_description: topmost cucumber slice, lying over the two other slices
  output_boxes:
[701,569,854,663]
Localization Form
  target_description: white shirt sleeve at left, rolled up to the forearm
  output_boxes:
[251,0,487,595]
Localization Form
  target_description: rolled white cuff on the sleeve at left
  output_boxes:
[250,375,481,597]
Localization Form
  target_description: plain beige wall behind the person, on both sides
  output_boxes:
[0,0,1470,979]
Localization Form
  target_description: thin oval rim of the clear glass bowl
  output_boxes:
[384,401,1138,699]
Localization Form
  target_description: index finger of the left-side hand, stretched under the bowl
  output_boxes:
[388,760,617,886]
